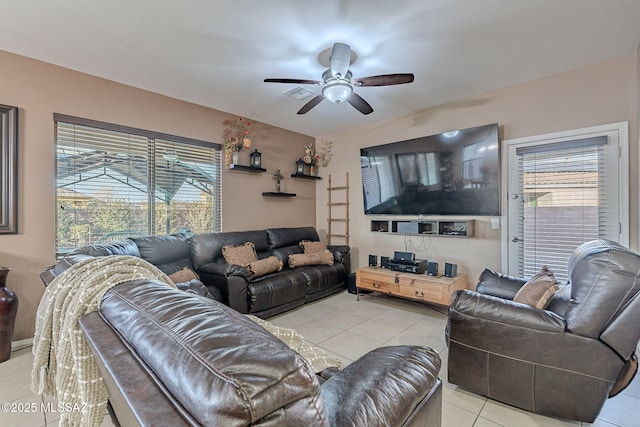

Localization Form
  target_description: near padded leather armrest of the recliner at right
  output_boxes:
[449,289,566,332]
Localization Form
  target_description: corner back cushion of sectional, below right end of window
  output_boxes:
[131,234,192,274]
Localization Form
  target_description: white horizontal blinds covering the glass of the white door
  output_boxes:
[516,136,617,282]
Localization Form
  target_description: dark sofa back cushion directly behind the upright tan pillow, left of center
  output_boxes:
[190,230,269,270]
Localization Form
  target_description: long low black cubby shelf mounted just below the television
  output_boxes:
[371,219,476,237]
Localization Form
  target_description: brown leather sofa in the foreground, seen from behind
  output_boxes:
[80,280,442,427]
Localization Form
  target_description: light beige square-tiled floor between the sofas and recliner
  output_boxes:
[0,292,640,427]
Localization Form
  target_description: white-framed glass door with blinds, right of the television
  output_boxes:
[504,124,629,283]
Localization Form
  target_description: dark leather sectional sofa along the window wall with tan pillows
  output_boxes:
[41,227,350,318]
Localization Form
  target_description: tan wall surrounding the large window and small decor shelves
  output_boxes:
[0,51,315,340]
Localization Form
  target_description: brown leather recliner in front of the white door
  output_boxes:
[447,240,640,422]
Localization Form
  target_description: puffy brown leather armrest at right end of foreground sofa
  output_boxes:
[321,346,442,426]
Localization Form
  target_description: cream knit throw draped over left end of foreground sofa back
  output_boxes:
[31,255,175,427]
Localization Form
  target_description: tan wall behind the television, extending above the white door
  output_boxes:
[316,54,638,285]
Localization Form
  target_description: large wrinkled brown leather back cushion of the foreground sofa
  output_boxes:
[100,281,326,426]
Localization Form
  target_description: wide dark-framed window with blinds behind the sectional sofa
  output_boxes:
[54,114,222,255]
